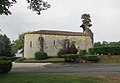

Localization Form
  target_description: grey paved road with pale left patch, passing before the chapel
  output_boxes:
[10,63,120,74]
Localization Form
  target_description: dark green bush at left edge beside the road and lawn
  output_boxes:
[0,60,12,73]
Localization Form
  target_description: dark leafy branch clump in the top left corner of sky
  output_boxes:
[0,0,16,15]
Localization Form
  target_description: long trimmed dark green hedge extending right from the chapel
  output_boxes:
[89,47,120,55]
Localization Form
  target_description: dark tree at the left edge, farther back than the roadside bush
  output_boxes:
[0,34,12,56]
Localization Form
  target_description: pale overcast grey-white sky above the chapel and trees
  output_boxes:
[0,0,120,42]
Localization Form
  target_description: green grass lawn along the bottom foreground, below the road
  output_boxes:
[0,73,117,83]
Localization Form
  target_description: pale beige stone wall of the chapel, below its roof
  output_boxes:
[24,34,93,58]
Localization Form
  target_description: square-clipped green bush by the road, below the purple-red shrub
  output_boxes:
[65,54,79,62]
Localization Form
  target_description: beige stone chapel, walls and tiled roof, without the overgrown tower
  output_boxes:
[24,30,93,58]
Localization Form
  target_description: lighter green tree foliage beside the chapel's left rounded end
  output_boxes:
[12,33,26,54]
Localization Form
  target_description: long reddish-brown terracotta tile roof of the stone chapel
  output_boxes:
[27,30,87,36]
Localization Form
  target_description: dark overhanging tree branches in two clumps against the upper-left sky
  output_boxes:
[0,0,51,15]
